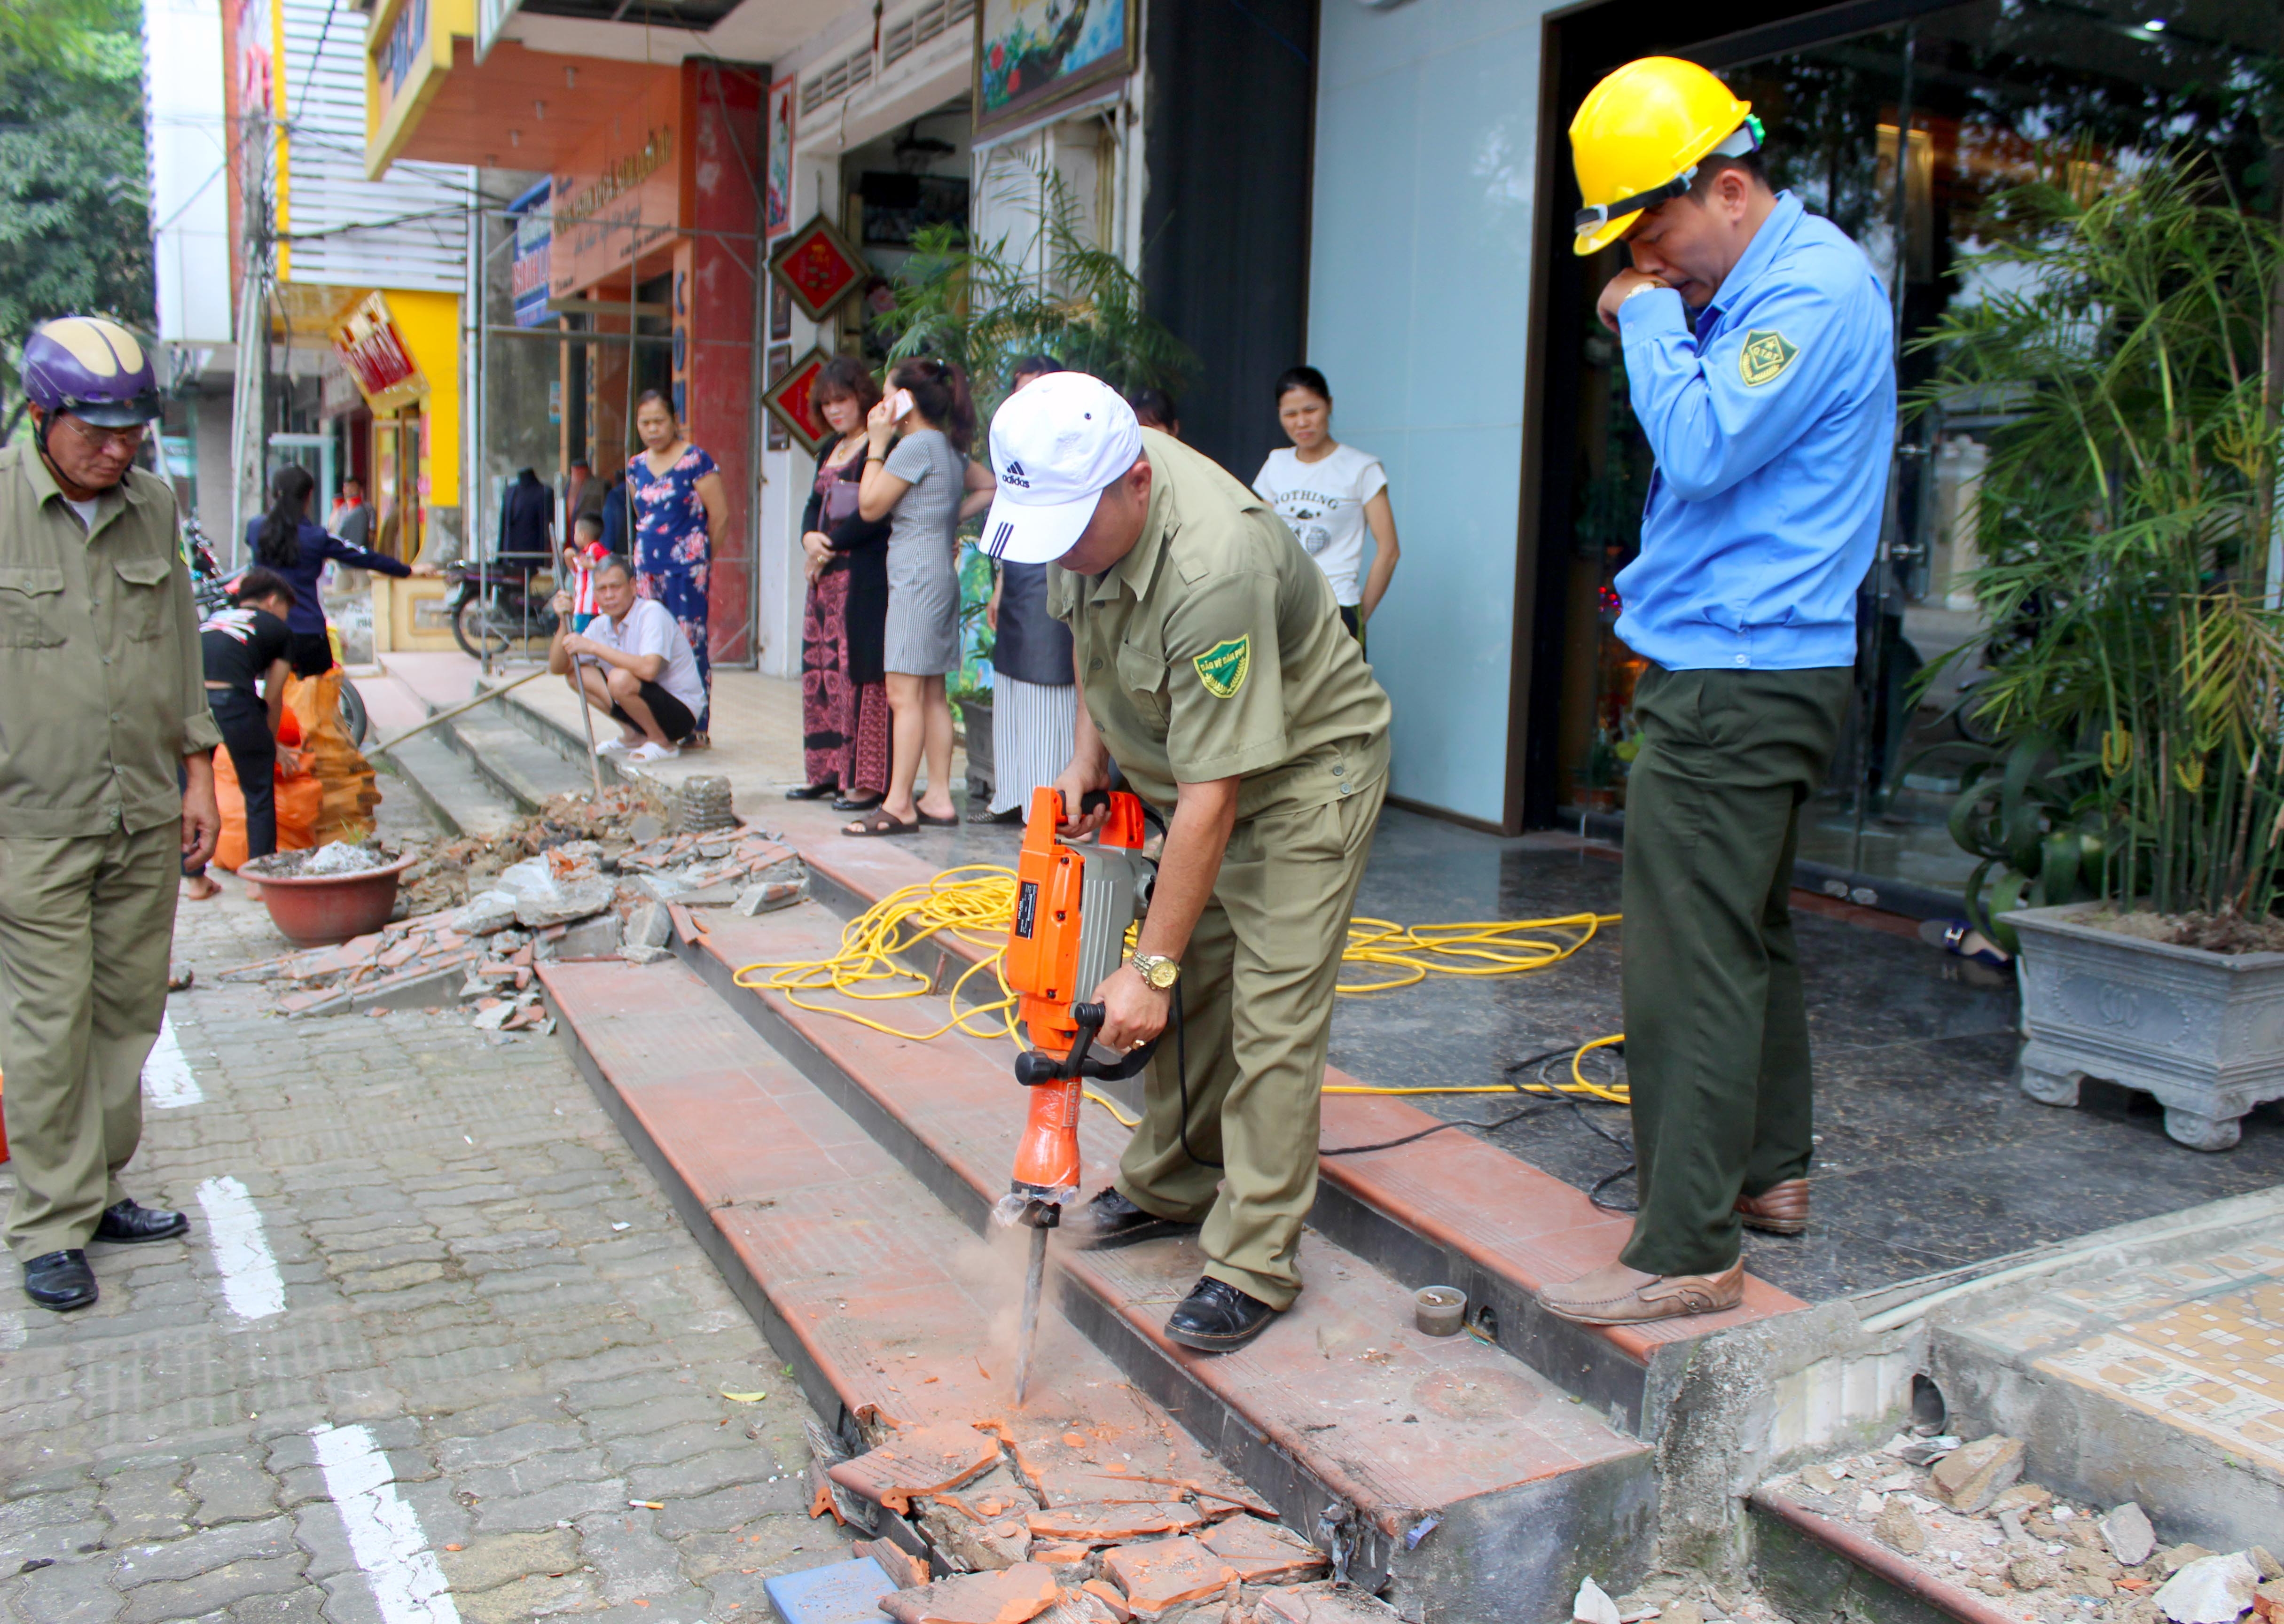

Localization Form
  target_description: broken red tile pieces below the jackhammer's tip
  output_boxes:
[808,1421,1395,1624]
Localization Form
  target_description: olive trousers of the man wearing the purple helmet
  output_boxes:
[0,822,183,1261]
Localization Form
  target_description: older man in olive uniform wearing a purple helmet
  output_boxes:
[0,318,221,1311]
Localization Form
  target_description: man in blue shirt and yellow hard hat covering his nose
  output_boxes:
[1544,57,1896,1325]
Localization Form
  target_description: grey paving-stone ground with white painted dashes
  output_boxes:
[0,886,847,1624]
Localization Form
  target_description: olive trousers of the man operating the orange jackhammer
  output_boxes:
[1119,779,1386,1309]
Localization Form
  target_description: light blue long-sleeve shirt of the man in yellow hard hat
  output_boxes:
[1617,192,1896,671]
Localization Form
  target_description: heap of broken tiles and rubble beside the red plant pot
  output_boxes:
[221,815,808,1032]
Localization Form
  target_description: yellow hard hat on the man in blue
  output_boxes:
[1572,57,1761,254]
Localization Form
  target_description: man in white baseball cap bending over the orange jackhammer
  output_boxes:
[985,372,1389,1352]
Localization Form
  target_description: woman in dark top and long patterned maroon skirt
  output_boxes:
[786,356,889,811]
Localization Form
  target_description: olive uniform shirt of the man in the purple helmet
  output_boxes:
[0,445,221,841]
